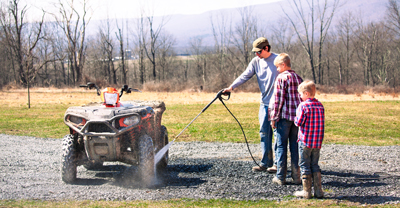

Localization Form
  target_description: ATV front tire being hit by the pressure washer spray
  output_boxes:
[138,134,155,185]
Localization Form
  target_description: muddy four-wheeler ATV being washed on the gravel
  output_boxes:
[61,82,168,183]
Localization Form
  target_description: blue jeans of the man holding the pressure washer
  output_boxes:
[258,104,273,167]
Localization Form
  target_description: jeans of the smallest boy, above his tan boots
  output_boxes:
[299,141,321,175]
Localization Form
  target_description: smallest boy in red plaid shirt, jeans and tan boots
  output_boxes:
[294,81,325,199]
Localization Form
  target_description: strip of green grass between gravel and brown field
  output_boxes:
[0,101,400,146]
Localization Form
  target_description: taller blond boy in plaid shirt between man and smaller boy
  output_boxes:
[269,53,303,185]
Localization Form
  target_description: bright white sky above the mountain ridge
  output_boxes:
[25,0,280,19]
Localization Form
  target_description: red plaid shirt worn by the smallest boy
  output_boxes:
[294,98,325,149]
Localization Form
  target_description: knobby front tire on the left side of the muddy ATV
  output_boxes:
[61,134,78,183]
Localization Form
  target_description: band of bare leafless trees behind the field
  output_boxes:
[0,0,400,91]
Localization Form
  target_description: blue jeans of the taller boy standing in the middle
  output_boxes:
[274,119,299,181]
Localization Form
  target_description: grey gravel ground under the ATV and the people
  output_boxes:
[0,134,400,204]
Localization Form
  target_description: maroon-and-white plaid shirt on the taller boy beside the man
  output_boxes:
[269,70,303,121]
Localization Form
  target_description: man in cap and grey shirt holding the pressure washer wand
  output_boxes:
[223,37,279,173]
